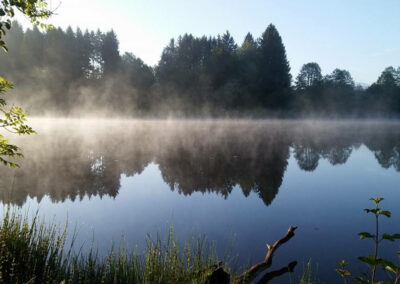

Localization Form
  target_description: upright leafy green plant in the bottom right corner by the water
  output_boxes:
[336,197,400,284]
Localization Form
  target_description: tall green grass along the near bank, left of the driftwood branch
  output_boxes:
[0,210,218,283]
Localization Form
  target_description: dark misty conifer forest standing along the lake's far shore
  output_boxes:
[0,22,400,117]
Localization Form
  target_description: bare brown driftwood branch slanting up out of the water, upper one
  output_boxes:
[233,226,297,283]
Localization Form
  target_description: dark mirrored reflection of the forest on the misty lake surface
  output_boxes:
[0,121,400,205]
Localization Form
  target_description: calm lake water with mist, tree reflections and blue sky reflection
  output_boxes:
[0,120,400,283]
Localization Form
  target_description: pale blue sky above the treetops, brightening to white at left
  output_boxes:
[19,0,400,84]
